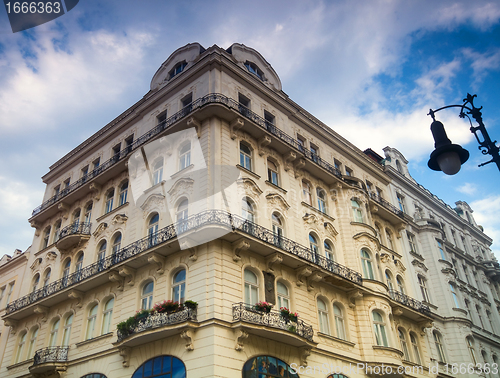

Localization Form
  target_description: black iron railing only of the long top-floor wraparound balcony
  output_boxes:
[31,93,342,217]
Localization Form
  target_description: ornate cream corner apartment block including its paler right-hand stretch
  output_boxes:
[0,43,500,378]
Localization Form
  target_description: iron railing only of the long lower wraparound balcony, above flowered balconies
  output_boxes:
[6,210,363,314]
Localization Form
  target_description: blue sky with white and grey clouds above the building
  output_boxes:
[0,0,500,257]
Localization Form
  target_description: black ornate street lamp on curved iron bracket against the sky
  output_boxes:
[427,93,500,175]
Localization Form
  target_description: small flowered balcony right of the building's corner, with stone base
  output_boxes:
[233,303,314,346]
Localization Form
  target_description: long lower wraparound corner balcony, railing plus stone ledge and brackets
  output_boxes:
[3,210,362,321]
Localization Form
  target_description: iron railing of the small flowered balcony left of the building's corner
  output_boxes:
[117,307,198,342]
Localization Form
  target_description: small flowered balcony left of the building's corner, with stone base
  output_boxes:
[117,307,197,346]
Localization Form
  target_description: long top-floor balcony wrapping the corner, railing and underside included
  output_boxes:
[30,93,350,225]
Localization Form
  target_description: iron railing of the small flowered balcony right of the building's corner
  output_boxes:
[233,303,314,341]
